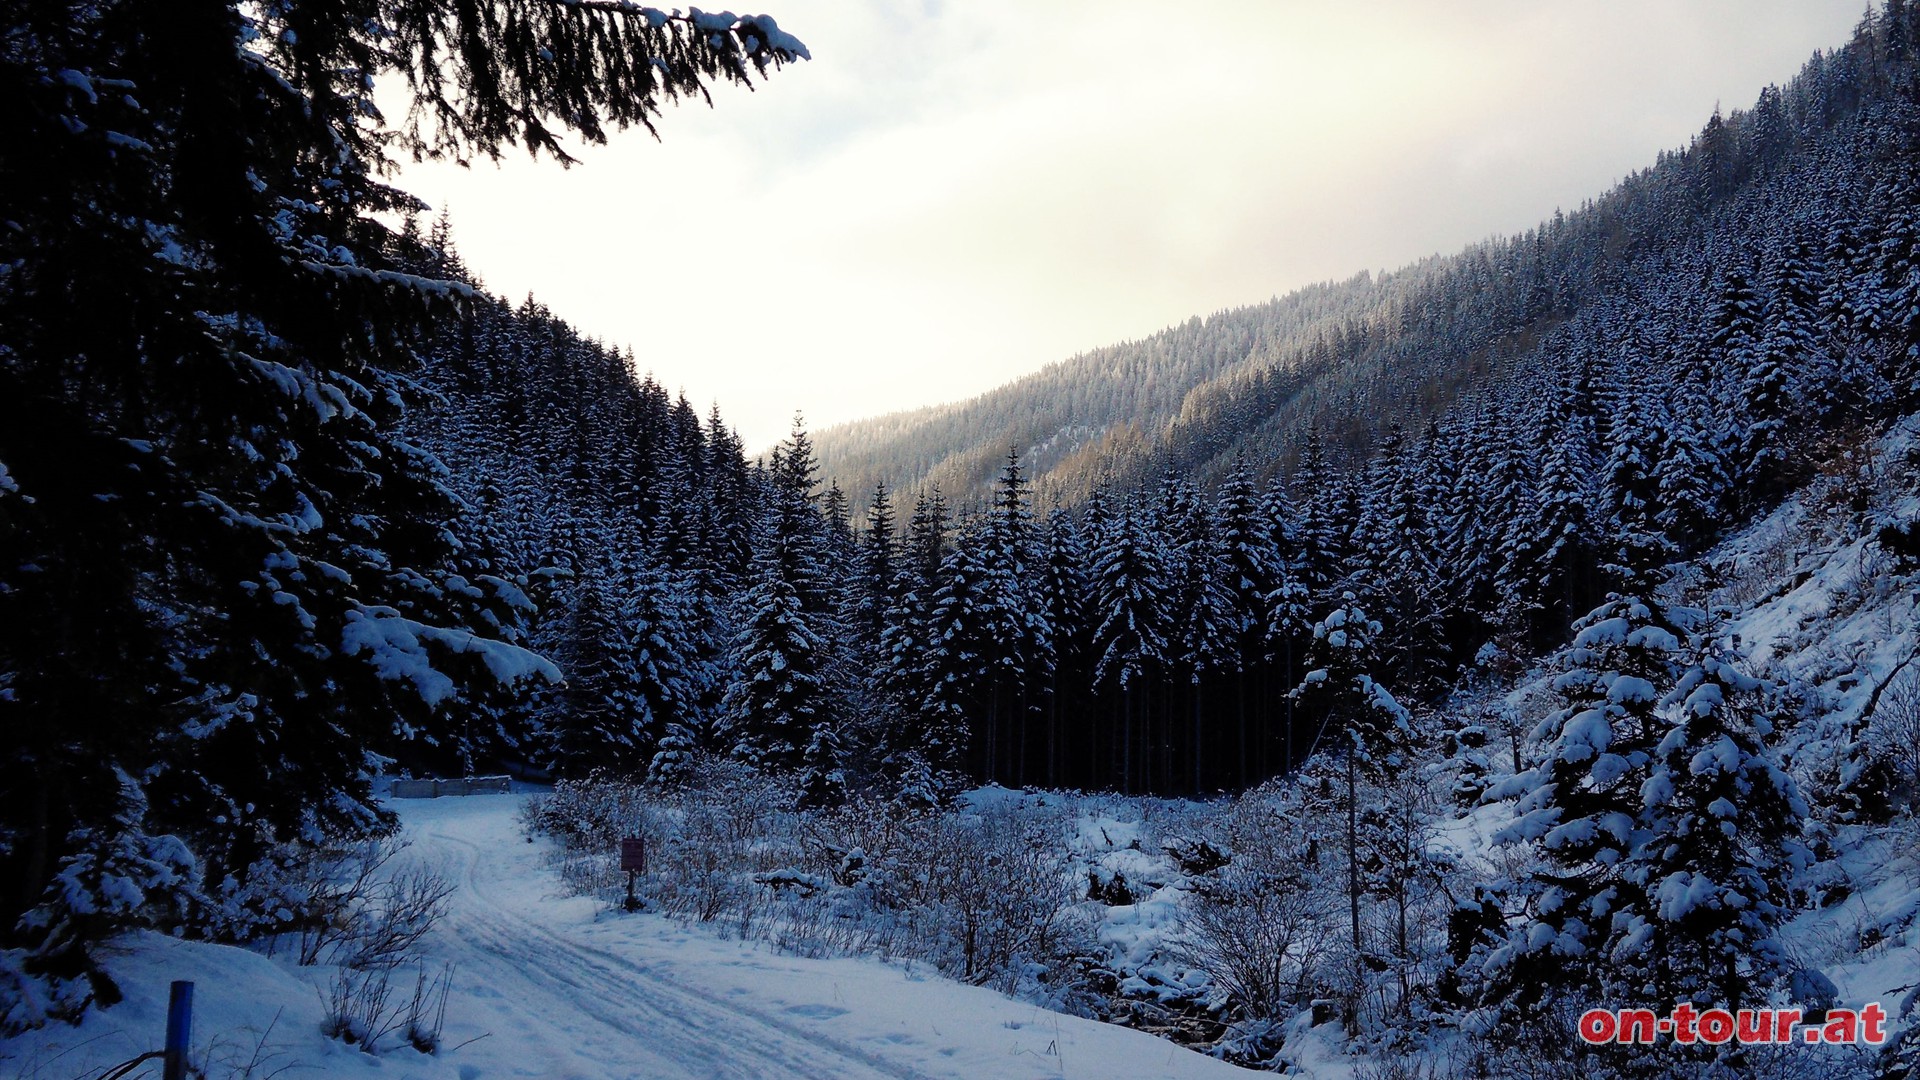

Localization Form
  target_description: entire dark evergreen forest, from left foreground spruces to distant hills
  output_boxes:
[11,0,1920,1060]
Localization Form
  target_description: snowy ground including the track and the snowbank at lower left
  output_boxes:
[0,796,1246,1080]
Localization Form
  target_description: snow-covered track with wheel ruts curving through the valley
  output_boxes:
[396,796,1242,1080]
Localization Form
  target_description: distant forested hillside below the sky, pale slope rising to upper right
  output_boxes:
[818,15,1907,502]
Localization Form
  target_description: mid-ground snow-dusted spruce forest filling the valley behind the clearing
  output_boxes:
[411,0,1920,799]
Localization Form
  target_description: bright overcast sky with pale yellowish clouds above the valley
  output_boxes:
[403,0,1862,450]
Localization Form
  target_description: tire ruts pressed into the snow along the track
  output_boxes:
[420,814,927,1080]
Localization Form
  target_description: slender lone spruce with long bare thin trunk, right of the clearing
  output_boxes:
[1292,592,1413,1030]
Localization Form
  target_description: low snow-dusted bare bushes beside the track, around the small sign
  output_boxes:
[526,763,1094,1009]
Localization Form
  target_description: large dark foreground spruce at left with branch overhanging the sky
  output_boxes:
[0,0,804,1022]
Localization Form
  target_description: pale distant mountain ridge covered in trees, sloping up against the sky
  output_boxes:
[816,23,1872,503]
